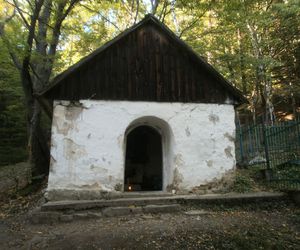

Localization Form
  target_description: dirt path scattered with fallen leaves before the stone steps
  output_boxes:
[0,204,300,249]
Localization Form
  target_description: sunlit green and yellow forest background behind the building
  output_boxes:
[0,0,300,175]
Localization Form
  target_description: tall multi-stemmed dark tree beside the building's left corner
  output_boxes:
[0,0,80,175]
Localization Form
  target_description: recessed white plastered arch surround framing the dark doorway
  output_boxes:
[124,116,175,191]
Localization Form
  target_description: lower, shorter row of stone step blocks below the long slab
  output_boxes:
[29,204,181,224]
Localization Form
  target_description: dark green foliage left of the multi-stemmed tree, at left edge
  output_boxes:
[0,40,28,166]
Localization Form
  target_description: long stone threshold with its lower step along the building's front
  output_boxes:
[29,192,289,224]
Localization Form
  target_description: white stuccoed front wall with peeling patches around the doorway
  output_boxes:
[48,100,235,197]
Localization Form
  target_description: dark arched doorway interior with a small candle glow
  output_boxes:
[124,126,162,191]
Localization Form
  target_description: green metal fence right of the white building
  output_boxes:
[236,118,300,190]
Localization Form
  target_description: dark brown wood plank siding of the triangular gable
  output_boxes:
[45,23,236,103]
